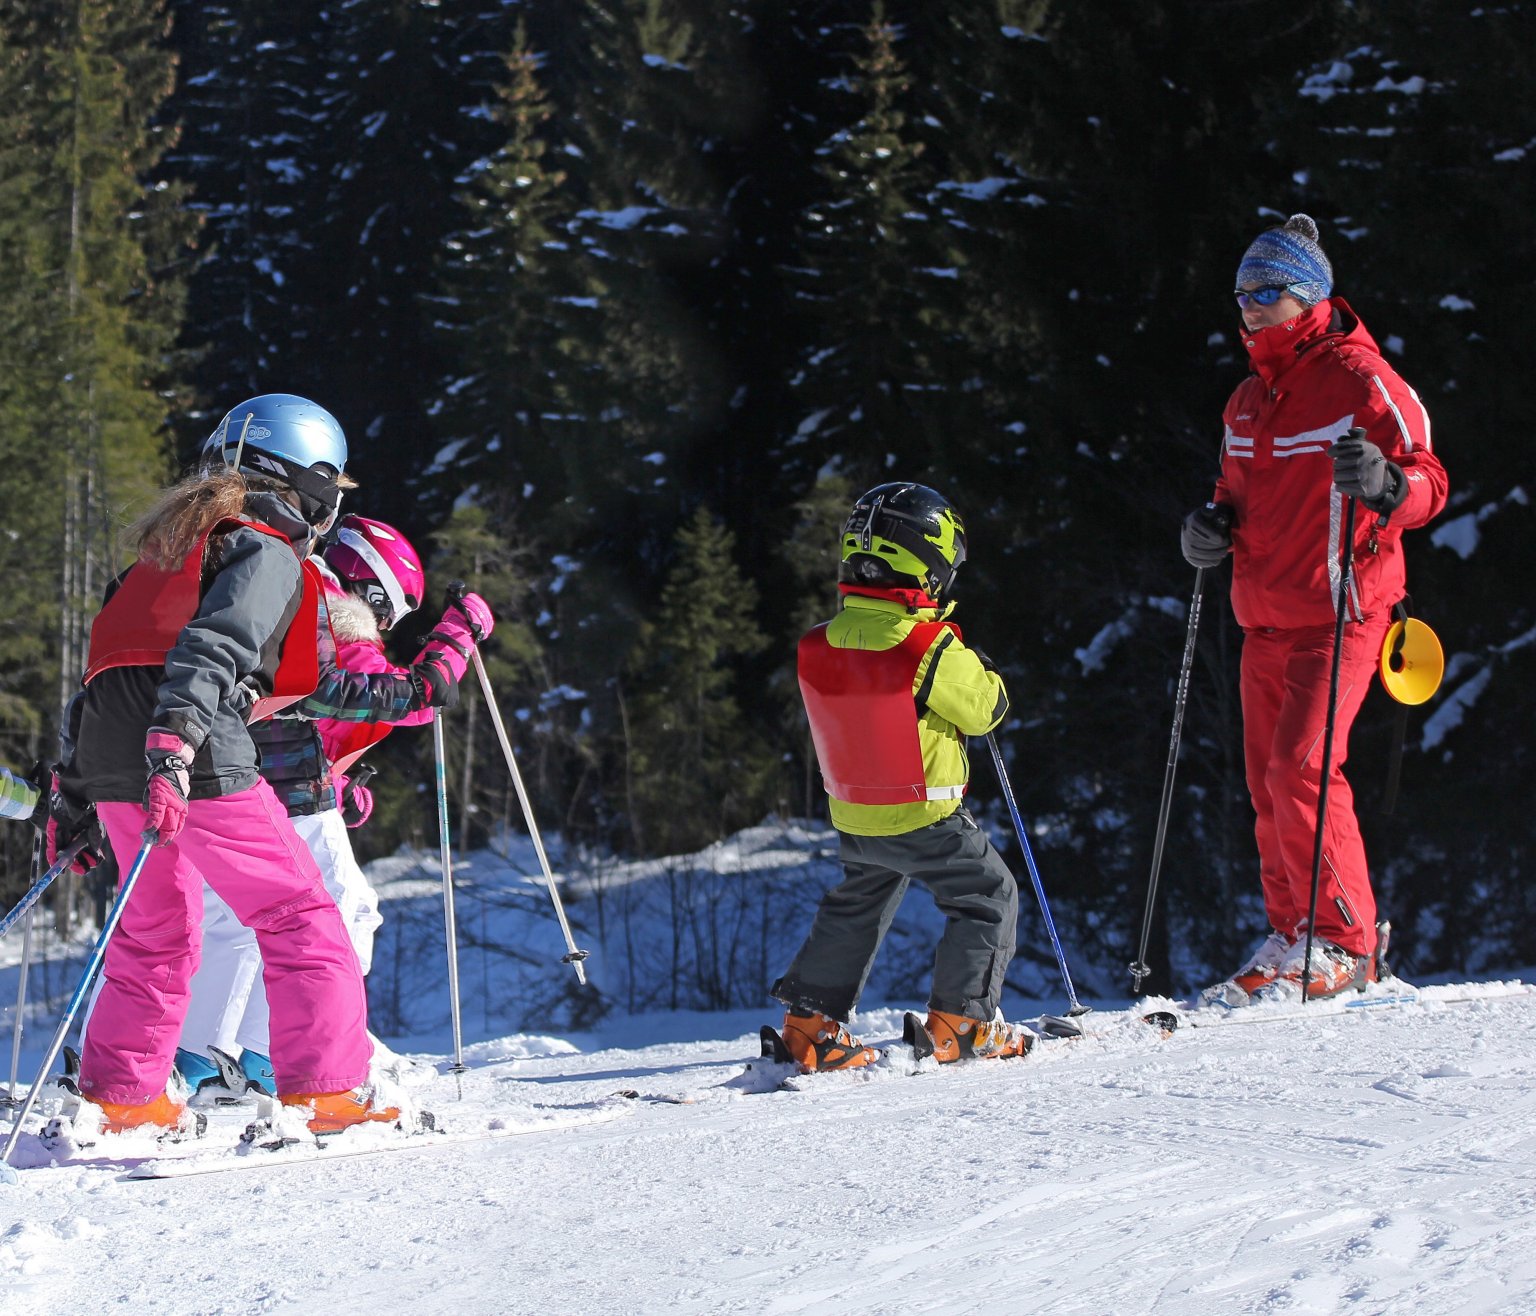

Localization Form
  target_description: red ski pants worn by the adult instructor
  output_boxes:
[1241,614,1392,955]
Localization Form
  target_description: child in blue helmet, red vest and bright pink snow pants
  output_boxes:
[60,393,399,1132]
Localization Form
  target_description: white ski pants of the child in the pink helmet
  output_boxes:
[181,809,384,1055]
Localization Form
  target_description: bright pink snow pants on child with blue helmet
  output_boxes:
[80,782,373,1104]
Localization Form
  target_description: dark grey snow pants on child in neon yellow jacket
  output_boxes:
[773,808,1018,1023]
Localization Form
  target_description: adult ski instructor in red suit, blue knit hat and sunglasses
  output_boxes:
[1181,215,1445,1004]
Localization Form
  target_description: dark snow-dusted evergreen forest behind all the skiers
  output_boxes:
[0,0,1536,983]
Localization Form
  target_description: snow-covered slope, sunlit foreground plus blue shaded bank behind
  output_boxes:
[0,825,1536,1316]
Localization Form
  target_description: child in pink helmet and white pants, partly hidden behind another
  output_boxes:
[177,516,495,1092]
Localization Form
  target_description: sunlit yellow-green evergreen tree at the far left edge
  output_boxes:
[0,0,190,764]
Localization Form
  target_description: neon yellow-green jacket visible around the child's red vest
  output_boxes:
[826,594,1008,837]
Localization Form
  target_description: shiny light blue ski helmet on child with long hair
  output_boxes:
[203,393,347,533]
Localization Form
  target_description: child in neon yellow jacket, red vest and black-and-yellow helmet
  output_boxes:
[773,484,1031,1069]
